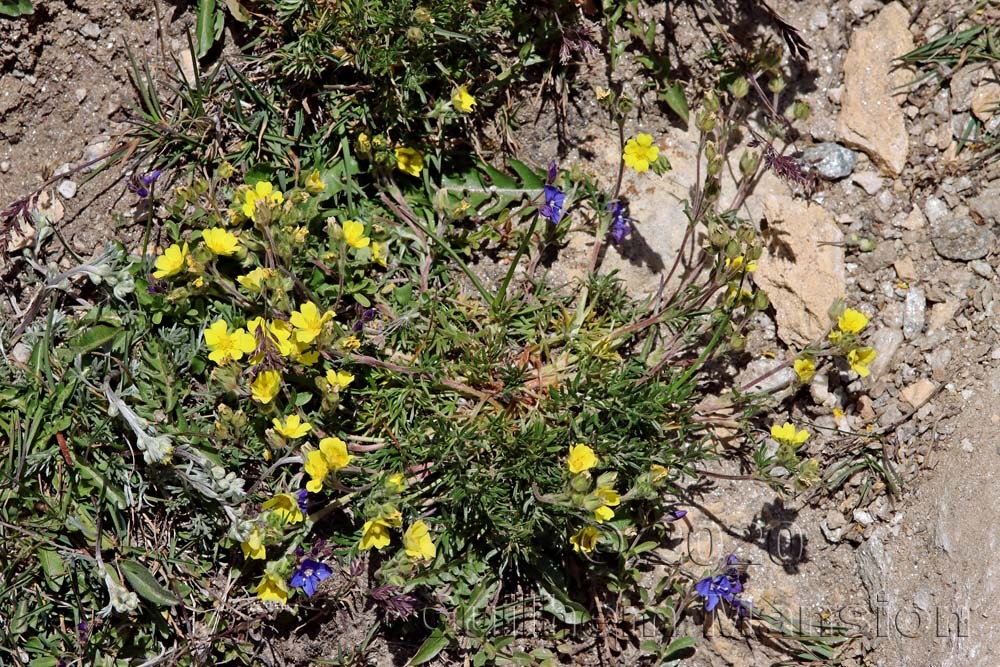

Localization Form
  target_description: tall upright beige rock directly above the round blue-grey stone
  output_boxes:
[837,2,913,175]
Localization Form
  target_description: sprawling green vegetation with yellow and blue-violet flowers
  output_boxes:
[0,0,873,666]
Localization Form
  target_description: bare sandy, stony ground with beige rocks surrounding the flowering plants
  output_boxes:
[0,0,1000,666]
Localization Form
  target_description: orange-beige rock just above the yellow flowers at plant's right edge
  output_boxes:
[753,195,846,346]
